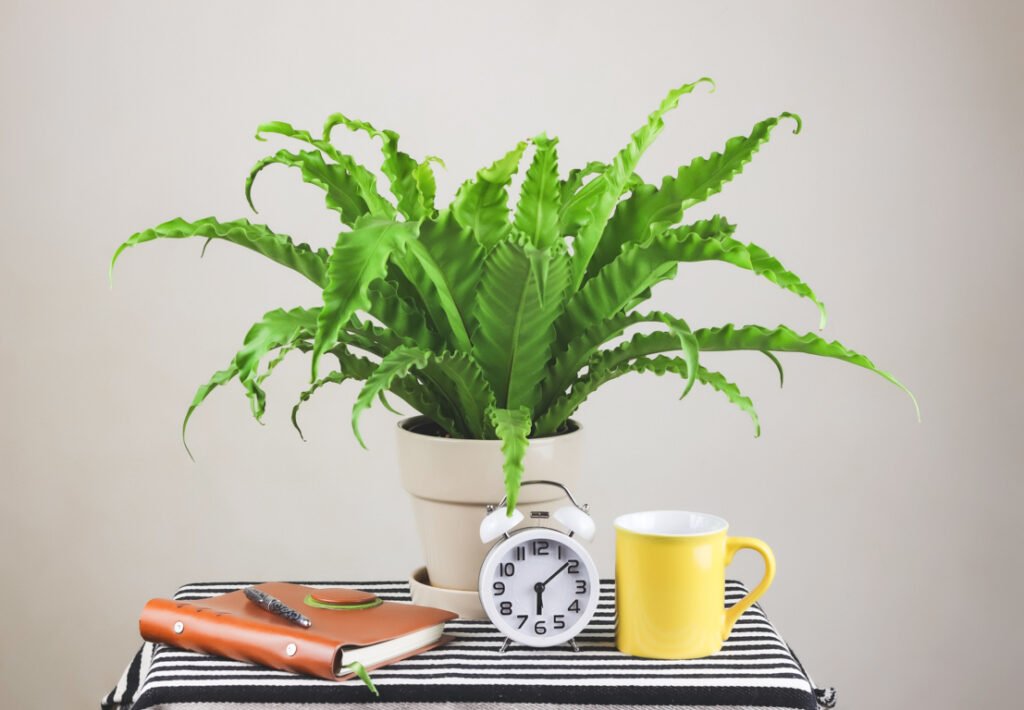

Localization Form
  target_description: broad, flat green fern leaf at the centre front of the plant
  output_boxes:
[473,242,569,409]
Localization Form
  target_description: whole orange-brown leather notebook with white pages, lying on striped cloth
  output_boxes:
[138,582,457,680]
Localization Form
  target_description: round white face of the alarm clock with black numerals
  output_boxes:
[480,528,600,646]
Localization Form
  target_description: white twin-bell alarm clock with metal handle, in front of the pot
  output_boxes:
[479,481,600,652]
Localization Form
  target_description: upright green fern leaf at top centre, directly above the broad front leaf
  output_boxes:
[515,133,561,249]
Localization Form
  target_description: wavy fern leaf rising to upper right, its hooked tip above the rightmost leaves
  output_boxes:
[587,113,800,279]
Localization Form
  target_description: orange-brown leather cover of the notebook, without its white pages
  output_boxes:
[138,582,457,680]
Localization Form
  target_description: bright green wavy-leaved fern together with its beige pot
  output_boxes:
[111,74,902,610]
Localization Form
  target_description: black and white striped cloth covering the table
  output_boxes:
[102,580,835,710]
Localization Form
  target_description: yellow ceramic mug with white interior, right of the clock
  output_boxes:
[615,510,775,659]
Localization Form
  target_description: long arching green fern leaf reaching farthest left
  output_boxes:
[110,217,328,286]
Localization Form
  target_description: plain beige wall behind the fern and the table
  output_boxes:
[0,0,1024,710]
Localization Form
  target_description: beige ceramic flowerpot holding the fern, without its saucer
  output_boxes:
[398,417,583,612]
